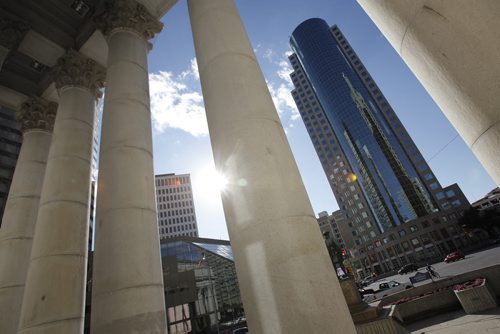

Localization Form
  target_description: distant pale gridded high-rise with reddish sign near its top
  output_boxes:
[155,174,198,238]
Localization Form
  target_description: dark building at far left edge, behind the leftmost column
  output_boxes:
[0,107,23,227]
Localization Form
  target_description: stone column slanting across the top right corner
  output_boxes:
[358,0,500,185]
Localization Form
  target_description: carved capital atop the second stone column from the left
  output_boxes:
[51,50,106,98]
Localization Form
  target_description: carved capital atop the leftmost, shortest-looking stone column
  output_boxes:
[16,96,57,132]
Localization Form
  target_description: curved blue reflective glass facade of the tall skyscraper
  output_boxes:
[290,19,437,232]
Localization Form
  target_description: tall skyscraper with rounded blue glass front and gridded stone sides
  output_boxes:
[289,19,469,273]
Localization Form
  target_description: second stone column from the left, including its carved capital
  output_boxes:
[18,51,105,334]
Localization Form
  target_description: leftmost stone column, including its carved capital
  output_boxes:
[0,97,57,333]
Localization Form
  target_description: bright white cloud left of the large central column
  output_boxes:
[149,59,208,136]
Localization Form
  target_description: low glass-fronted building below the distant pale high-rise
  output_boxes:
[161,238,244,333]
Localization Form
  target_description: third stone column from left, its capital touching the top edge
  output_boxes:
[91,0,167,334]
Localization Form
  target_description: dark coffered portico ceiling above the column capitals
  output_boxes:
[0,0,177,108]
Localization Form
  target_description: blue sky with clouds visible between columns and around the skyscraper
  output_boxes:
[149,0,495,239]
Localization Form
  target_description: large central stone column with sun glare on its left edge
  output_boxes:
[188,0,355,334]
